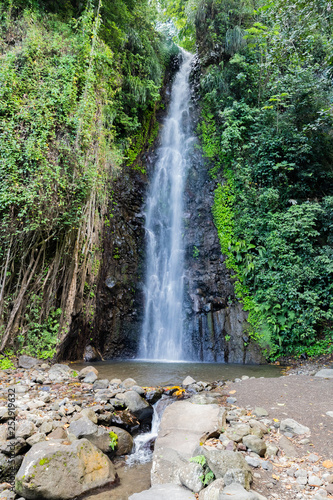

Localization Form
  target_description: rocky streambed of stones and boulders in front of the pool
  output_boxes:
[0,356,333,500]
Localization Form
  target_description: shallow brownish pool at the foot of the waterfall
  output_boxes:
[71,360,282,387]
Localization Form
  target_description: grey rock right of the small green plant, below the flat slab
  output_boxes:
[202,446,252,489]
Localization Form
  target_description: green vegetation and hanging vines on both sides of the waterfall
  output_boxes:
[0,0,333,359]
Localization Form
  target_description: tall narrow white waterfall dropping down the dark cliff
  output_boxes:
[139,50,194,361]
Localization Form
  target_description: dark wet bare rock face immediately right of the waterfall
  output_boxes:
[184,93,263,363]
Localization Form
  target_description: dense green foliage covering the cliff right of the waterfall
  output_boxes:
[197,0,333,359]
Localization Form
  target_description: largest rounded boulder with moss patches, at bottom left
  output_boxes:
[15,439,116,500]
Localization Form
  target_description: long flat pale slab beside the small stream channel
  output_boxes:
[151,400,225,484]
